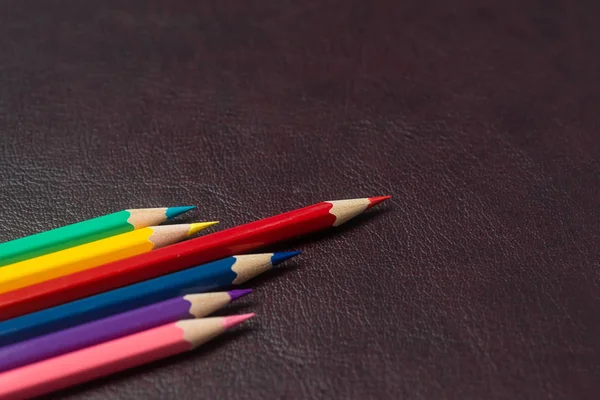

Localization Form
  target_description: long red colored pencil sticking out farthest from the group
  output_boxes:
[0,196,389,318]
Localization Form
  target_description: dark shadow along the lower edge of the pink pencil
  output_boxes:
[36,326,254,400]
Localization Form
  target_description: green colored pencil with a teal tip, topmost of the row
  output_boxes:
[0,206,196,266]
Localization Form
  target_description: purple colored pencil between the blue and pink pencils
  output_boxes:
[0,289,252,372]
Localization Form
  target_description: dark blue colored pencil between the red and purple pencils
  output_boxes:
[0,252,292,346]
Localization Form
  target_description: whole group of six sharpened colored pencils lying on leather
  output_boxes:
[0,196,389,399]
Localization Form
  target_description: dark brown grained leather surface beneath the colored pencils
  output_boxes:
[0,0,600,400]
